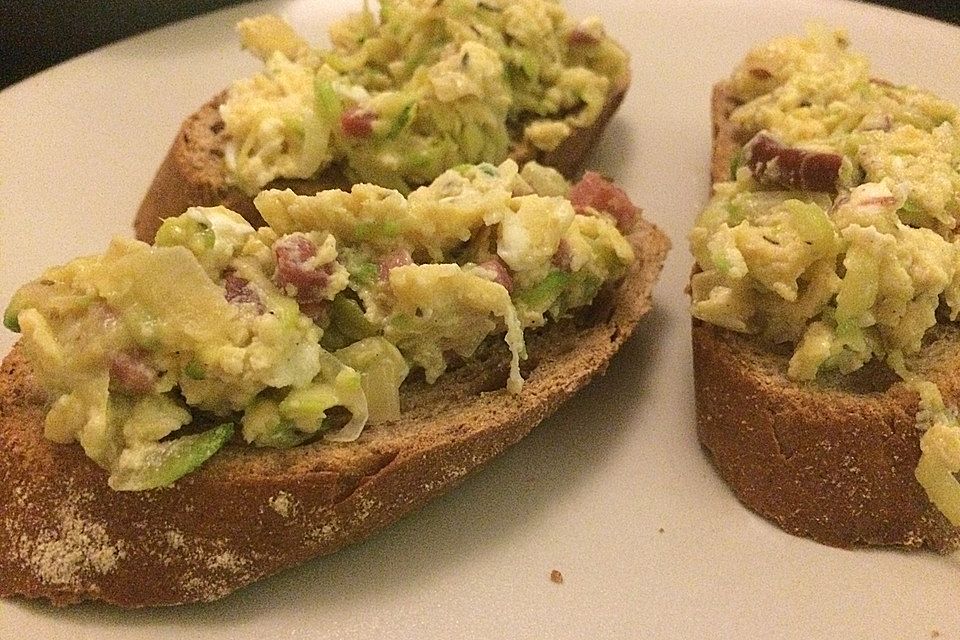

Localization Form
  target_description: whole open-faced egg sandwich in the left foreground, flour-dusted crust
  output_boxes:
[0,160,669,607]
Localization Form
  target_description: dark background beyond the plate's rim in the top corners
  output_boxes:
[0,0,960,88]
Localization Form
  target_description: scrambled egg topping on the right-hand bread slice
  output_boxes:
[690,28,960,524]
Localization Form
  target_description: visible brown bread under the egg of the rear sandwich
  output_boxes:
[133,73,630,242]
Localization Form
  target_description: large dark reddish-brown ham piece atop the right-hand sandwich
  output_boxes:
[743,131,843,192]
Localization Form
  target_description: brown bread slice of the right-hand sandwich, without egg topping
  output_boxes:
[692,84,960,551]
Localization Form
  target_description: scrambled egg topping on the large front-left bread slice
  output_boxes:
[4,160,636,490]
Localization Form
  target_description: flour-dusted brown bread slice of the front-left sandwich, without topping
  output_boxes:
[0,220,669,607]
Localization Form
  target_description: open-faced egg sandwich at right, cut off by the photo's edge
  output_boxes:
[690,27,960,550]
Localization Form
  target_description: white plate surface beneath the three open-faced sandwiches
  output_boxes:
[0,0,960,640]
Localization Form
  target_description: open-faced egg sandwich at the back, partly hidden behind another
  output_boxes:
[135,0,630,241]
